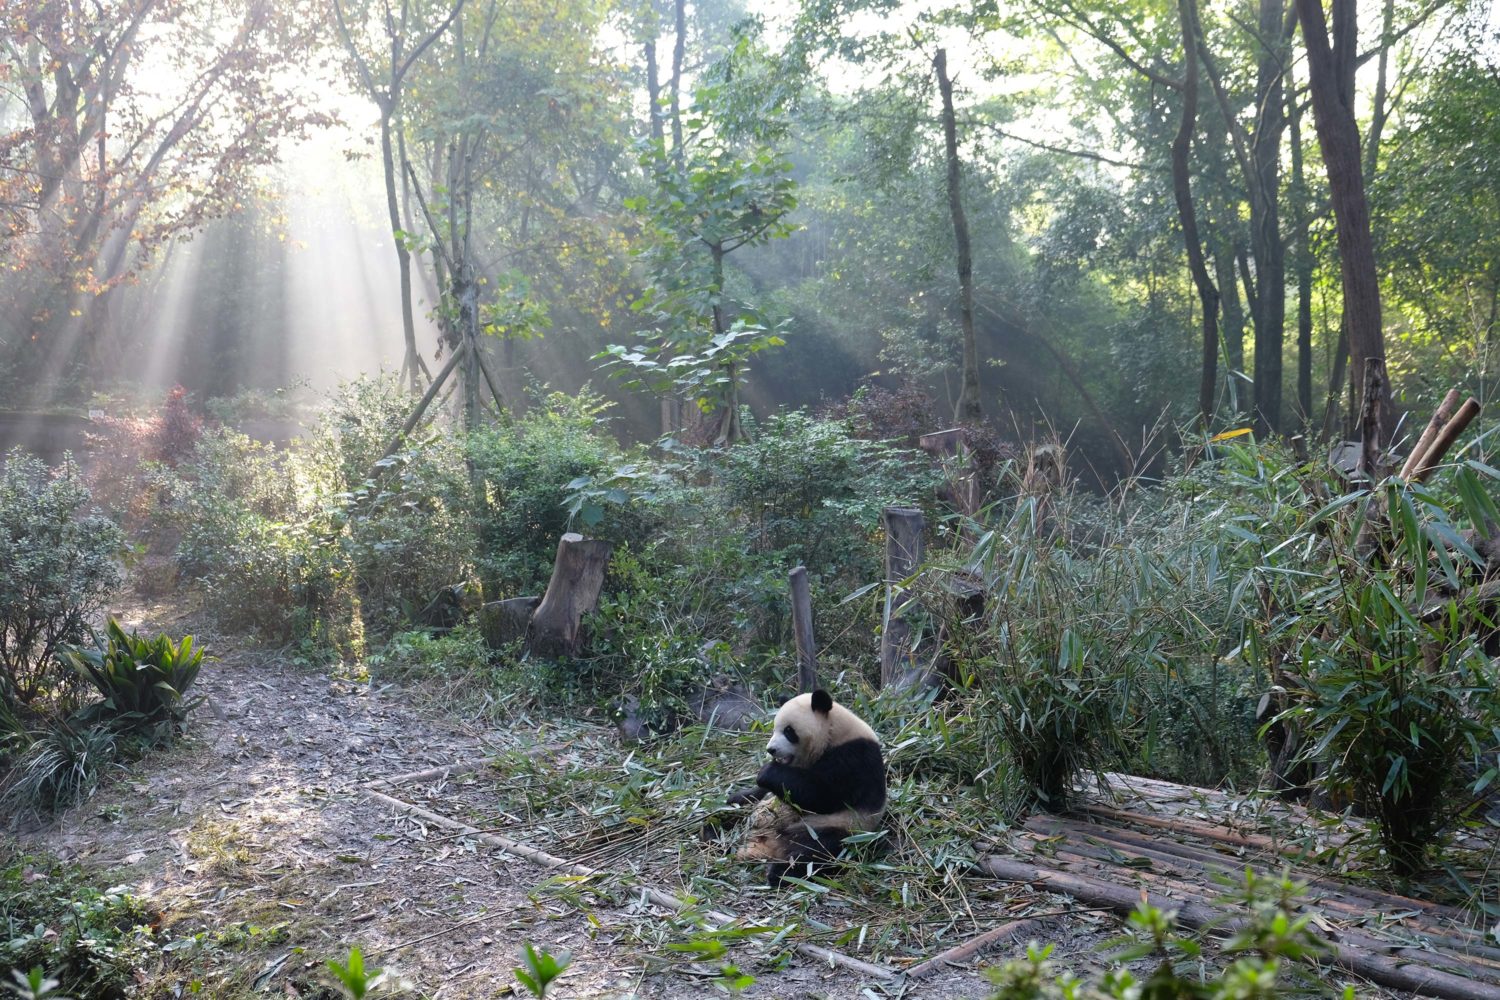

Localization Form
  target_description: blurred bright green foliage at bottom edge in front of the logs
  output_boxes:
[989,871,1353,1000]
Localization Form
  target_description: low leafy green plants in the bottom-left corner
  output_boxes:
[0,855,158,1000]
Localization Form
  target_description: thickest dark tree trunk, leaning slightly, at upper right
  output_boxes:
[1296,0,1395,433]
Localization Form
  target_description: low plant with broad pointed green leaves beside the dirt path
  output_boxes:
[60,618,203,732]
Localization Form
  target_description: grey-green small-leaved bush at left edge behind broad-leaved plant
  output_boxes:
[0,450,123,712]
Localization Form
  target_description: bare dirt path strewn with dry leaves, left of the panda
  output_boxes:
[11,605,986,1000]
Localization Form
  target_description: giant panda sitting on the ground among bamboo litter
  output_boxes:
[729,690,885,889]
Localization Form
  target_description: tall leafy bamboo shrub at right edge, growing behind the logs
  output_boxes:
[1269,474,1500,877]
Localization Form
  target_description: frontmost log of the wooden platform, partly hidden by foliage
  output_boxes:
[980,856,1500,1000]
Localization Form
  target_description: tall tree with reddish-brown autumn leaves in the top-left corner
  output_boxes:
[0,0,327,402]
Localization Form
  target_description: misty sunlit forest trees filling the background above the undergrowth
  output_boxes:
[0,0,1500,474]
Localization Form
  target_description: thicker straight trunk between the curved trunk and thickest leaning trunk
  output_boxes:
[1250,0,1287,433]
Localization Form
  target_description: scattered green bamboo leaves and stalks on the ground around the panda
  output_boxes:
[444,691,1025,961]
